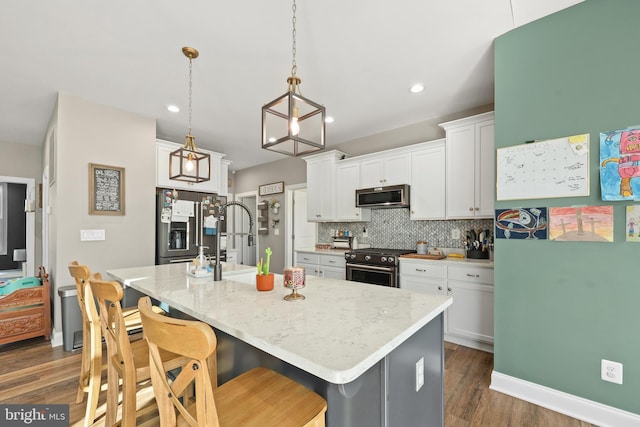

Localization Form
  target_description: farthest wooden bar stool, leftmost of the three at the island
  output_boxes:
[69,261,164,427]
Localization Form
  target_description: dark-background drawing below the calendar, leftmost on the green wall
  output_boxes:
[494,208,547,239]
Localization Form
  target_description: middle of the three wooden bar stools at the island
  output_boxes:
[84,275,187,427]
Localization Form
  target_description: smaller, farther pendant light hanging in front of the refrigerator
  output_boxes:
[169,47,211,183]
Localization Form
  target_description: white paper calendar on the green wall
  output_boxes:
[496,134,589,200]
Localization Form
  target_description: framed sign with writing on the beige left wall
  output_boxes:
[89,163,125,215]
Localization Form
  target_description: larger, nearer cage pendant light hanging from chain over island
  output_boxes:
[262,0,325,156]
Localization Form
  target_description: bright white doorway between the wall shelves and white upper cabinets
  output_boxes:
[285,184,318,265]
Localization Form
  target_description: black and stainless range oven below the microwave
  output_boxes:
[344,248,415,288]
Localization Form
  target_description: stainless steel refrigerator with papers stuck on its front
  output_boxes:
[156,188,227,264]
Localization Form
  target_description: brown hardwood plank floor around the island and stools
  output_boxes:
[0,338,595,427]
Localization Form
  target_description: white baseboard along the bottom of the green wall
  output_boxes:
[489,371,640,427]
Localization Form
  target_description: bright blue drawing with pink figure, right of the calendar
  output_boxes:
[600,129,640,200]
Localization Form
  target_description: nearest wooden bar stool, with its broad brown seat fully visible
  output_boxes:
[138,297,327,427]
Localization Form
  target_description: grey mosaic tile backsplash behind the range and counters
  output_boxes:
[318,208,493,249]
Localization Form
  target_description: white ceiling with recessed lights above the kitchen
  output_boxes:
[0,0,581,170]
